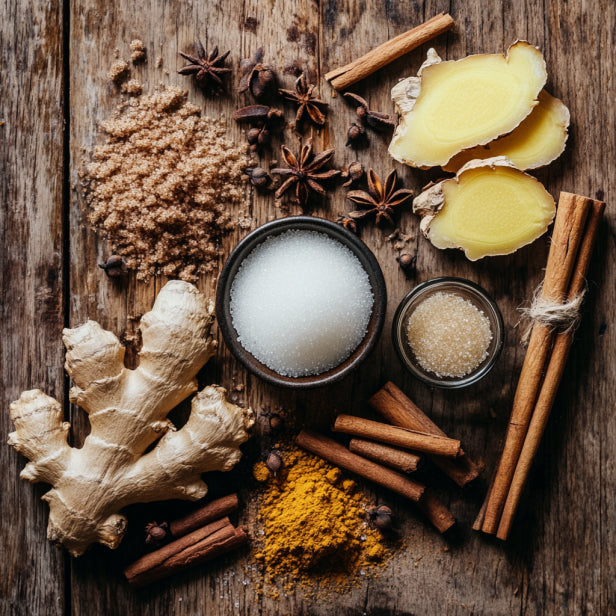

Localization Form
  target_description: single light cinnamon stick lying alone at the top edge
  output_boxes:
[325,13,454,90]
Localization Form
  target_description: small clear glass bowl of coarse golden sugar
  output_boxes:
[392,277,504,389]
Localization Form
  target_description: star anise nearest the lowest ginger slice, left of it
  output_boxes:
[347,169,413,225]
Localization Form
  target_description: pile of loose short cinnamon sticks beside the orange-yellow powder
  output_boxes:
[297,382,480,533]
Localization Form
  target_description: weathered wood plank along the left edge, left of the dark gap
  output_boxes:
[0,1,64,615]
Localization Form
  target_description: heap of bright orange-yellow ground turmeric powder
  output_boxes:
[253,448,390,591]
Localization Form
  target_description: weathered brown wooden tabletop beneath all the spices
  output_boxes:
[0,0,616,616]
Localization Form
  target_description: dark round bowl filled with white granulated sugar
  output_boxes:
[216,216,387,388]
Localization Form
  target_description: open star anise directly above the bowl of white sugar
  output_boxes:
[270,139,340,210]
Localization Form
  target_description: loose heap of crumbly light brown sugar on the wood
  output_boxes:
[86,87,250,282]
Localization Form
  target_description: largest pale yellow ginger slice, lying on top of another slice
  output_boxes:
[389,41,547,168]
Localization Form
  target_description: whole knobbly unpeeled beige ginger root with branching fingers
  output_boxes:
[9,280,254,556]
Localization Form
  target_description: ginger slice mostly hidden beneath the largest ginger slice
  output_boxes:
[443,90,569,173]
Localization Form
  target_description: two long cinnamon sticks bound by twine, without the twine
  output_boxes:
[473,193,605,540]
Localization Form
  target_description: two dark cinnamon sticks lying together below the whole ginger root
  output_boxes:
[124,494,248,587]
